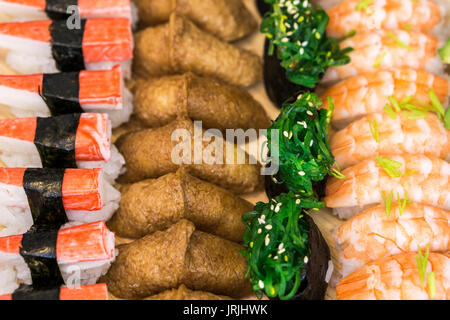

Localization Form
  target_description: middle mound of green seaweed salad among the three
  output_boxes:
[267,92,335,197]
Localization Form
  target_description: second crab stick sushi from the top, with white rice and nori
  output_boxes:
[0,18,133,78]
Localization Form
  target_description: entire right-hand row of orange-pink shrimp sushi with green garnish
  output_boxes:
[321,0,450,300]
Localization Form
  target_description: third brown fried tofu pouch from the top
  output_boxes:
[132,72,271,131]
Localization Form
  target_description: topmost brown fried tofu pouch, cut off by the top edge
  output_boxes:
[134,0,257,41]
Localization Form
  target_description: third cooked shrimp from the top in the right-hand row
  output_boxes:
[321,69,450,129]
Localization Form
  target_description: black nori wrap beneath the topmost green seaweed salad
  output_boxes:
[263,39,313,109]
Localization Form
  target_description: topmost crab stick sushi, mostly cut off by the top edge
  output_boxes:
[0,0,134,21]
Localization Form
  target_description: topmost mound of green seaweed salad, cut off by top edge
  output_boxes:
[261,0,353,88]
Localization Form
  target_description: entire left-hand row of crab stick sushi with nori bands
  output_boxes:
[0,1,138,300]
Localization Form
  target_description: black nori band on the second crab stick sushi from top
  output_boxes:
[49,19,86,72]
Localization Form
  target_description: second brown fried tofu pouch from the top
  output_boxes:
[134,13,262,86]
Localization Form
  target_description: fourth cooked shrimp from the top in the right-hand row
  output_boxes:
[330,112,450,169]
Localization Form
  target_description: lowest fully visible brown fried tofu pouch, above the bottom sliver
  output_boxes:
[100,219,255,299]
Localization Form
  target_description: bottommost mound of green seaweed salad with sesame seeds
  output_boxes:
[242,192,324,300]
